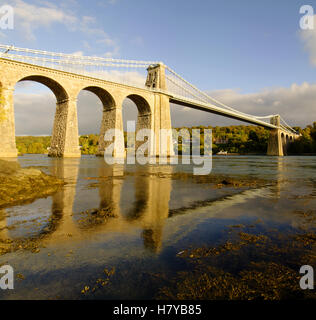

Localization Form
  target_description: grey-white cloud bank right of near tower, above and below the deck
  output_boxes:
[171,82,316,127]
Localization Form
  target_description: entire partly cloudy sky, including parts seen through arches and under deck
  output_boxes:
[0,0,316,135]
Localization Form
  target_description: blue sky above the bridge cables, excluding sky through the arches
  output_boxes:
[0,0,316,132]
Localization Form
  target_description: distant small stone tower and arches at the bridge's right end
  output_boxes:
[267,116,299,156]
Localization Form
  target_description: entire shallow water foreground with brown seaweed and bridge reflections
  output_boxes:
[0,155,316,300]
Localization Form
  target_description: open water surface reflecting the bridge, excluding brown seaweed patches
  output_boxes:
[0,155,316,299]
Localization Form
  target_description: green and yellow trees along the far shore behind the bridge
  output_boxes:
[16,122,316,154]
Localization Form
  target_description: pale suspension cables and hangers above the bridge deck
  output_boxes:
[0,44,296,133]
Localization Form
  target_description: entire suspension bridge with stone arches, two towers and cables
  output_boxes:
[0,45,299,157]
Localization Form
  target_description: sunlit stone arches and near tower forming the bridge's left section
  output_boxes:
[0,58,174,158]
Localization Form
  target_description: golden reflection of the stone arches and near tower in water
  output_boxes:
[0,159,172,252]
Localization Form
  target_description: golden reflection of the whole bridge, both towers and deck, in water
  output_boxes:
[0,158,307,252]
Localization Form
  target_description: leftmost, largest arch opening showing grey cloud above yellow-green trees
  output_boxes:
[13,76,61,154]
